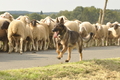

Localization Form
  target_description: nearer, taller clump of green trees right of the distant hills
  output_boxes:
[55,6,120,24]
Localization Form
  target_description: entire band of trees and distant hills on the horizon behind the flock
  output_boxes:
[0,6,120,24]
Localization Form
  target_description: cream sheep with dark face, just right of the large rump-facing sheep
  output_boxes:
[30,20,49,51]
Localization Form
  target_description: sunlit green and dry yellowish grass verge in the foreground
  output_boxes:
[0,58,120,80]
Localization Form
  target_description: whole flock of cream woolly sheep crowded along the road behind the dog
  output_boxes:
[0,12,120,53]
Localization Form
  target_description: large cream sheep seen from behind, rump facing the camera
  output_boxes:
[8,16,34,53]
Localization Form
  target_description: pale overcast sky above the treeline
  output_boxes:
[0,0,120,12]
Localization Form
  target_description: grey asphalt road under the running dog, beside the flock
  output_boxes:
[0,46,120,70]
